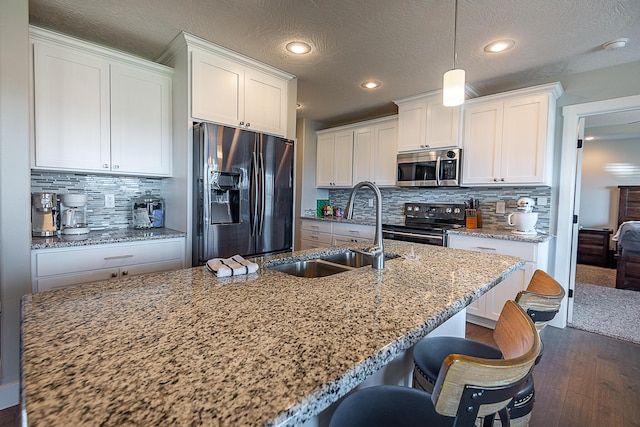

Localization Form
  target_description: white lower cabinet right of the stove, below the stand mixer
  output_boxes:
[448,234,549,328]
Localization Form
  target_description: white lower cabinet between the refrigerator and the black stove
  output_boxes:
[300,219,375,250]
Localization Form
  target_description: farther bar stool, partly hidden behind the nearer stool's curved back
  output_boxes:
[413,270,564,427]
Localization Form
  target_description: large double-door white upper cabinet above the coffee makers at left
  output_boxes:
[30,27,172,176]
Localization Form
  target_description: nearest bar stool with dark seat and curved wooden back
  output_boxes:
[329,301,540,427]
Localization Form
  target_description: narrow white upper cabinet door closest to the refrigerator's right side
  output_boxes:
[316,129,353,187]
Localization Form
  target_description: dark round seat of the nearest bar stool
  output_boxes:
[329,385,455,427]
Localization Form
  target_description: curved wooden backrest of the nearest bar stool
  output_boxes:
[431,301,540,425]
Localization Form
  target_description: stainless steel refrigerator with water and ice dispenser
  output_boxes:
[193,123,294,265]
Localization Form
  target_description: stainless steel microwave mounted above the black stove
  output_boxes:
[396,148,462,187]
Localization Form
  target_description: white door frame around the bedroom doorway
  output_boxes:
[553,95,640,328]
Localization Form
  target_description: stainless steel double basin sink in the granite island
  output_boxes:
[266,250,398,278]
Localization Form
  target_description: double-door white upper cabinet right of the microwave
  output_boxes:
[462,83,562,186]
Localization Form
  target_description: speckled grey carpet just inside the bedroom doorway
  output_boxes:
[569,282,640,344]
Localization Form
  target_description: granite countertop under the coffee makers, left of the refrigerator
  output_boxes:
[31,228,185,249]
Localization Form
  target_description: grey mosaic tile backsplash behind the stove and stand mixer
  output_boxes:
[329,187,552,233]
